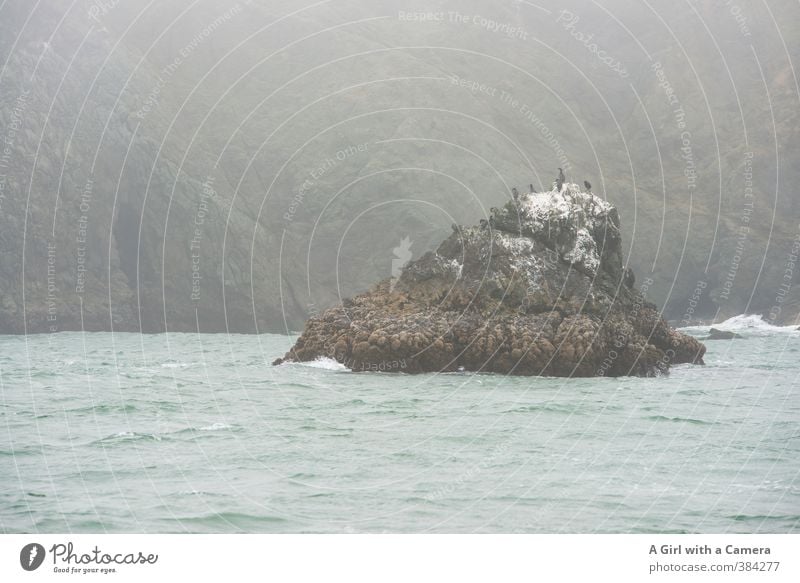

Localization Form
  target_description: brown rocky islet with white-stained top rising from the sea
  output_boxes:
[273,183,705,377]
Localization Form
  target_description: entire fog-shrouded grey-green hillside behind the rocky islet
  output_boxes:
[0,0,800,333]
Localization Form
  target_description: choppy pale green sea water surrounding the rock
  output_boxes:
[0,318,800,533]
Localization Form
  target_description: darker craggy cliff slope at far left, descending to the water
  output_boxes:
[0,0,294,334]
